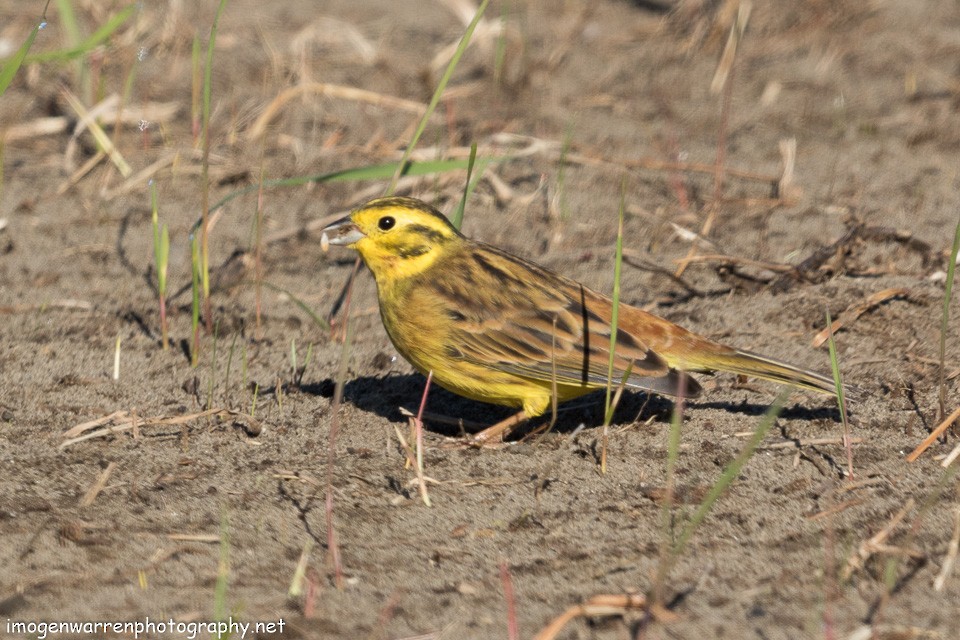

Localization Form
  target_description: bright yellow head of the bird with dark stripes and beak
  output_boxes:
[323,197,466,282]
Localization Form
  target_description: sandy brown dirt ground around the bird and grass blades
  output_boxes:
[0,0,960,640]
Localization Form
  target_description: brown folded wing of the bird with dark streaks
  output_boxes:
[435,243,700,396]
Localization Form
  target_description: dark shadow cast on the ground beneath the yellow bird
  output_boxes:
[300,374,840,436]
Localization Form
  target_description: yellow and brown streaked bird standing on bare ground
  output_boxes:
[323,197,835,442]
